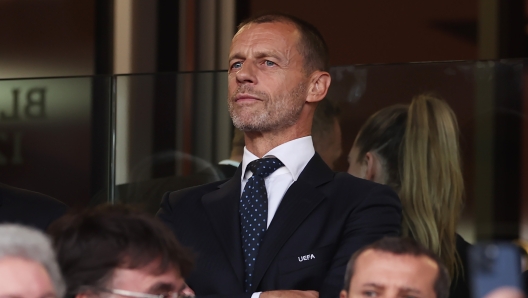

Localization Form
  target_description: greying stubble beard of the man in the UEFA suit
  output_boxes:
[228,82,306,132]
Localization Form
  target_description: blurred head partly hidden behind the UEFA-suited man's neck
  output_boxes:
[312,98,342,170]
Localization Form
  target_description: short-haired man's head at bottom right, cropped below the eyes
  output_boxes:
[340,237,450,298]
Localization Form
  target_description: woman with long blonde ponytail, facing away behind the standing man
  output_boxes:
[348,94,471,298]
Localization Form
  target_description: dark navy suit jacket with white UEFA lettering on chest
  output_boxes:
[158,153,401,298]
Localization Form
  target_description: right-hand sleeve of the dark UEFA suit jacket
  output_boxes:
[319,185,401,298]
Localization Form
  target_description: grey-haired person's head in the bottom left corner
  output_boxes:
[0,224,65,298]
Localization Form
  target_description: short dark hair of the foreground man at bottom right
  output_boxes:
[343,237,451,298]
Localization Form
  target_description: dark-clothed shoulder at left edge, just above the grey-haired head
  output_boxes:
[0,183,67,231]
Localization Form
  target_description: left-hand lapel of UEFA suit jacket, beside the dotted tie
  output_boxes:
[202,167,244,287]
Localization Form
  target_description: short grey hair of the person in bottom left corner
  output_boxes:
[0,224,66,298]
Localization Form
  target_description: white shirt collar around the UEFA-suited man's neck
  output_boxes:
[241,136,315,181]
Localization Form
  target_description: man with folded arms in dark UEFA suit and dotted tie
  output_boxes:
[158,15,401,298]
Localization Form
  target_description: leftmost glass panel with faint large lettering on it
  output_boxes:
[0,77,110,211]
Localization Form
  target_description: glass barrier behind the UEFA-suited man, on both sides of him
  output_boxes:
[0,60,528,242]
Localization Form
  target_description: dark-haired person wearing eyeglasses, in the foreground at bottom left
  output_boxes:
[49,205,194,298]
